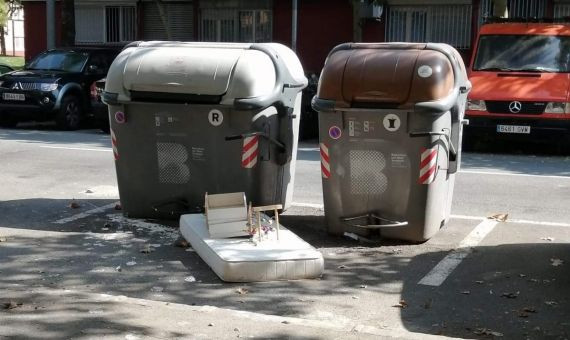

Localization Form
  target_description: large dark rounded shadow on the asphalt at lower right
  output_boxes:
[401,243,570,339]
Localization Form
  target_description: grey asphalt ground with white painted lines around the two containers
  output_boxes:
[0,127,570,339]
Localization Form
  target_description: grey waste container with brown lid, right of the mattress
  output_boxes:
[313,43,471,242]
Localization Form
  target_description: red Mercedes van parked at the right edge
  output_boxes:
[466,22,570,143]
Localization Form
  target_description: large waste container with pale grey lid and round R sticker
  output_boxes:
[103,42,307,218]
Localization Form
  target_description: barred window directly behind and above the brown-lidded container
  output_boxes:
[386,5,472,49]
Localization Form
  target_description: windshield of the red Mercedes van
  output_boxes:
[473,35,570,72]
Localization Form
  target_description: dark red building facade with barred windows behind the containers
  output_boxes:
[23,0,570,73]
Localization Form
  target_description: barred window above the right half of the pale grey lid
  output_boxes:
[200,8,273,42]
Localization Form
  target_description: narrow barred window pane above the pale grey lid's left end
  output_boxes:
[105,6,136,43]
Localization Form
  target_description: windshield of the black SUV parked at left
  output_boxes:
[27,51,89,72]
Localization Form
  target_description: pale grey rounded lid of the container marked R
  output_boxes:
[105,41,307,107]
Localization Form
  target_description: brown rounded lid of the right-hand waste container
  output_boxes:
[316,43,466,108]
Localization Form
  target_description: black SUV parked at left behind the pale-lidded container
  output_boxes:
[0,47,120,130]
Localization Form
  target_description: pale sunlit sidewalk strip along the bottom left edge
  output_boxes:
[0,285,450,340]
